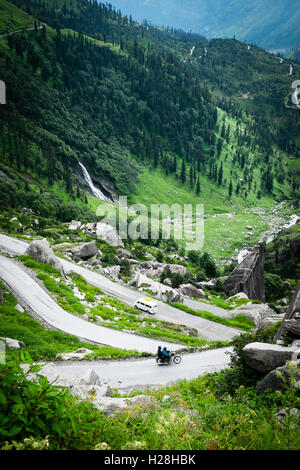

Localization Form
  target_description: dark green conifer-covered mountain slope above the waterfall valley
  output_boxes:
[0,0,300,229]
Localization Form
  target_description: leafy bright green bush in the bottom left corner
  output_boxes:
[0,363,79,446]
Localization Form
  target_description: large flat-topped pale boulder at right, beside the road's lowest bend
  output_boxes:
[243,343,297,373]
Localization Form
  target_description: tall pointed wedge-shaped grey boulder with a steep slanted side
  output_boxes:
[224,244,265,302]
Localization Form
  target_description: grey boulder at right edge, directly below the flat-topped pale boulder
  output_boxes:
[256,360,300,393]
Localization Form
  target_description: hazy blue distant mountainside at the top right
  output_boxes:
[112,0,300,52]
